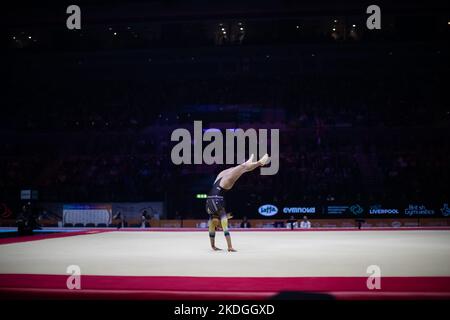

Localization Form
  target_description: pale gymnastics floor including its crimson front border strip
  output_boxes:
[0,230,450,299]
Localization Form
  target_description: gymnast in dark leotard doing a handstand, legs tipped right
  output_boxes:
[206,154,269,252]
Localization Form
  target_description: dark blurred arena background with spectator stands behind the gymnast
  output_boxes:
[0,1,450,217]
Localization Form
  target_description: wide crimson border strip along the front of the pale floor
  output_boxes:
[0,274,450,300]
